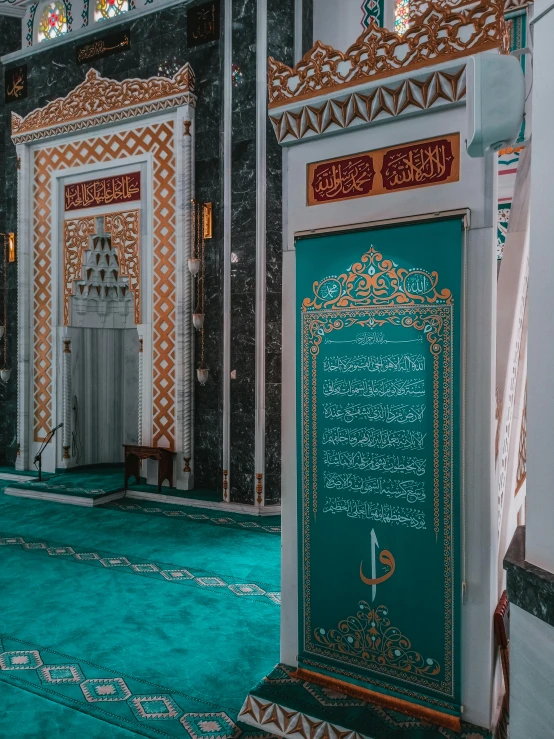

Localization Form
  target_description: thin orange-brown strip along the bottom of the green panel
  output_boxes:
[291,667,461,732]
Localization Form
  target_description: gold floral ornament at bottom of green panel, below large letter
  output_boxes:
[314,600,441,676]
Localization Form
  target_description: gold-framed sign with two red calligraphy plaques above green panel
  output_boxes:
[308,133,460,205]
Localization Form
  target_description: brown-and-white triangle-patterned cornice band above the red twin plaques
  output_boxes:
[270,63,466,143]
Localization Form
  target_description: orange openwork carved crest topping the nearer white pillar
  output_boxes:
[268,0,509,108]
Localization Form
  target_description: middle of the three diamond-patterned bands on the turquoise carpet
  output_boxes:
[0,533,281,608]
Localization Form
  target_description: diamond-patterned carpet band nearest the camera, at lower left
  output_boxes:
[0,634,273,739]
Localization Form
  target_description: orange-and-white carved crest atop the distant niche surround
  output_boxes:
[12,63,196,144]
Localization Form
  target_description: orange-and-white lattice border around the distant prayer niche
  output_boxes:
[33,121,176,449]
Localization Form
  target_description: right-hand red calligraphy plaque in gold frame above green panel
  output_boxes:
[381,138,456,190]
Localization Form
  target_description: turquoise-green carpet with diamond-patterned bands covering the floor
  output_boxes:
[0,488,280,739]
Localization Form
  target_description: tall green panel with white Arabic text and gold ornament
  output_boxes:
[296,218,463,716]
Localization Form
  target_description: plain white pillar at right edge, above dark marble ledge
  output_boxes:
[525,0,554,572]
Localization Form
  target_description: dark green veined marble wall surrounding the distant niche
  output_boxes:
[0,0,300,503]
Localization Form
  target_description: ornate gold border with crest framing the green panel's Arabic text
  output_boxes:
[301,304,454,697]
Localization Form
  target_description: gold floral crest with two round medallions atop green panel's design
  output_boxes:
[302,246,453,311]
